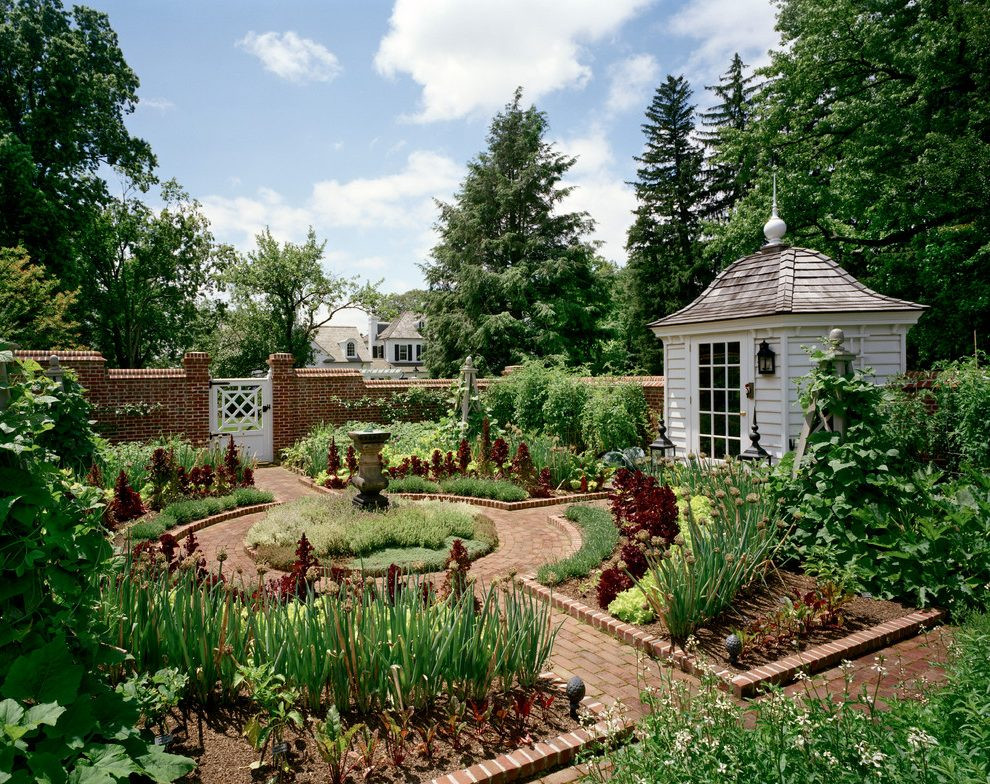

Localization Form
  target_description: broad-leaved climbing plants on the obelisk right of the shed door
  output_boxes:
[773,346,990,612]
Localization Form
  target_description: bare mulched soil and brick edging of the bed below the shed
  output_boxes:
[517,572,942,697]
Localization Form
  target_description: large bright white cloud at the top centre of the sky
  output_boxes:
[375,0,651,122]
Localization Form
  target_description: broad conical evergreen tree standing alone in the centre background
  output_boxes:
[423,89,608,376]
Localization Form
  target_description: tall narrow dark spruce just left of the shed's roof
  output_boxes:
[626,76,713,373]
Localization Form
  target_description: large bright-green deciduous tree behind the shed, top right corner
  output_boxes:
[708,0,990,365]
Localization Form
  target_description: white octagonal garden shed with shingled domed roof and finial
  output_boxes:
[649,204,926,460]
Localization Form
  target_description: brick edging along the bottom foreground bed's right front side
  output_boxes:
[430,677,633,784]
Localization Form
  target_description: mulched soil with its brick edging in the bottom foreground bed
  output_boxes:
[156,680,604,784]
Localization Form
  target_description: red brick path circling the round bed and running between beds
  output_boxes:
[178,467,948,784]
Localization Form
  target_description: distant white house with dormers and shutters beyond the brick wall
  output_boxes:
[313,311,425,378]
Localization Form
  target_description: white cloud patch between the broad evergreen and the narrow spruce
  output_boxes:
[557,126,636,264]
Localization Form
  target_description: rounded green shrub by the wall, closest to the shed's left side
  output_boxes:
[581,383,649,454]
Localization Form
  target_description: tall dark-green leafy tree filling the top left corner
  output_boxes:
[0,0,155,282]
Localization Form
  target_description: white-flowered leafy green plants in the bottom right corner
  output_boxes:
[592,615,990,784]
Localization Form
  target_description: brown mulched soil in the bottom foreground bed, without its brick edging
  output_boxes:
[168,690,579,784]
